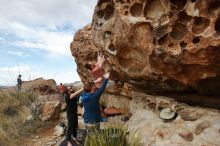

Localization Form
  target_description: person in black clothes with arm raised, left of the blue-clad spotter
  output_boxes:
[64,86,83,146]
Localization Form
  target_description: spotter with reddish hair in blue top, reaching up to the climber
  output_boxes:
[82,78,108,134]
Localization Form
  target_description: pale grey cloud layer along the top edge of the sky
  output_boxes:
[0,0,97,29]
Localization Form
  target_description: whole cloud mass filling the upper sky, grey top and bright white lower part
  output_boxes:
[0,0,97,55]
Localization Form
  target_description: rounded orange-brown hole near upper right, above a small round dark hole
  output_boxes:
[192,17,210,34]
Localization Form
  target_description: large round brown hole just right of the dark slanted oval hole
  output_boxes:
[170,23,187,40]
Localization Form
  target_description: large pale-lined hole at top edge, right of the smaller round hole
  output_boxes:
[144,0,164,19]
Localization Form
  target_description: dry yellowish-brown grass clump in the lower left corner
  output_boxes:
[0,90,40,146]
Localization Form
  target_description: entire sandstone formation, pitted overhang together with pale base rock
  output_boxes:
[71,0,220,146]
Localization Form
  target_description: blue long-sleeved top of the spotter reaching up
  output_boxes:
[82,79,108,123]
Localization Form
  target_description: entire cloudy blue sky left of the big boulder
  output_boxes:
[0,0,97,85]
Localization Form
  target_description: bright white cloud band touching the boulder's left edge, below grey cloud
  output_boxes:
[2,23,73,55]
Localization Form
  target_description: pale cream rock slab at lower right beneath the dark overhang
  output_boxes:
[128,92,220,146]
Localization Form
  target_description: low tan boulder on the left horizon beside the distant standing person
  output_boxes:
[22,78,57,95]
